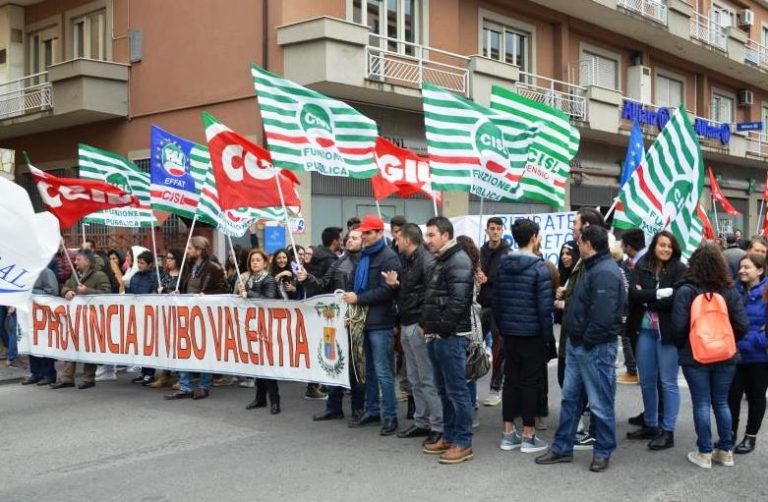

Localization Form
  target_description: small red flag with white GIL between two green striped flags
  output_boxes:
[371,137,440,201]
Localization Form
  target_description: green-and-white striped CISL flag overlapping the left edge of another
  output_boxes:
[421,83,535,201]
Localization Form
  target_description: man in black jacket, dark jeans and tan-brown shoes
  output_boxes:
[420,216,475,464]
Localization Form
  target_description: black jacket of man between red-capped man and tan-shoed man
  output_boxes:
[397,246,435,326]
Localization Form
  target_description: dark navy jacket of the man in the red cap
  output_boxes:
[350,240,400,331]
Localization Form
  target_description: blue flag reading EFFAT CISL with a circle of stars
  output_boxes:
[149,125,200,218]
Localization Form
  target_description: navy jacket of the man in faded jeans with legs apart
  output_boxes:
[565,250,627,350]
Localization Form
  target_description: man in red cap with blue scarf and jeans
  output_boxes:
[344,214,400,436]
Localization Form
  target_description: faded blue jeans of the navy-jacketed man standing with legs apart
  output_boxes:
[551,340,618,458]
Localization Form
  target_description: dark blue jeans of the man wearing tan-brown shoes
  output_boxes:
[427,336,474,448]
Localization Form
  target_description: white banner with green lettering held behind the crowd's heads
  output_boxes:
[451,211,576,264]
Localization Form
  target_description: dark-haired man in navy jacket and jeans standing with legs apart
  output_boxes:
[536,225,627,472]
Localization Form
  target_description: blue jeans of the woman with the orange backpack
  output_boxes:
[683,364,736,453]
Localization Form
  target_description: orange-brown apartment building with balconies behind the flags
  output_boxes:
[0,0,768,251]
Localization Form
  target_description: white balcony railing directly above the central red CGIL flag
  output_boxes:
[365,35,469,95]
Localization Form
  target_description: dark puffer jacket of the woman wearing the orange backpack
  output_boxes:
[672,282,749,366]
